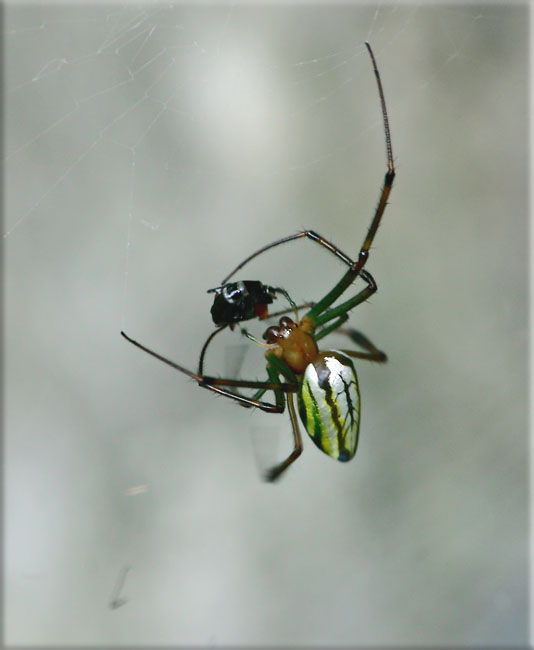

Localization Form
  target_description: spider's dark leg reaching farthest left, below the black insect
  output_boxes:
[121,332,298,413]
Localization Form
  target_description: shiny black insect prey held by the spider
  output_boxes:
[208,280,277,326]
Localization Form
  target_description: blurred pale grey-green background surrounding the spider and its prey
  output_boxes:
[4,3,528,646]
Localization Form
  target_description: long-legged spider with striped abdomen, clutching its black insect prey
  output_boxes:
[121,42,395,481]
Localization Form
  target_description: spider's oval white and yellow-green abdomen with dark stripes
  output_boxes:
[298,351,360,462]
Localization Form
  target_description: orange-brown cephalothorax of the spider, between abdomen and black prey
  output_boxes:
[263,316,318,375]
